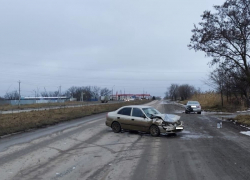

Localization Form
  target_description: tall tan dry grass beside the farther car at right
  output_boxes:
[183,93,246,112]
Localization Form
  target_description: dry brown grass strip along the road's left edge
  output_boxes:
[0,100,150,136]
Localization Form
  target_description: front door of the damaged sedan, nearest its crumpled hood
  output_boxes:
[131,108,151,131]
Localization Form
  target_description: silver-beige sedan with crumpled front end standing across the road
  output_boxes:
[106,105,184,136]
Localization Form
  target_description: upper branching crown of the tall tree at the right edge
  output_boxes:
[188,0,250,84]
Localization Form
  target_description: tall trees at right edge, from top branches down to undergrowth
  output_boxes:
[188,0,250,106]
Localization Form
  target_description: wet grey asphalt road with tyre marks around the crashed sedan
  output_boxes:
[0,102,250,180]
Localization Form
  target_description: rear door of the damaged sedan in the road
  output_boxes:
[116,107,132,130]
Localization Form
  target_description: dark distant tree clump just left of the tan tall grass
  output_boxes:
[165,84,200,101]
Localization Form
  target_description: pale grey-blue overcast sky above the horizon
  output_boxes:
[0,0,224,96]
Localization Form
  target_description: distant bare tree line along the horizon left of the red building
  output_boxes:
[0,86,112,101]
